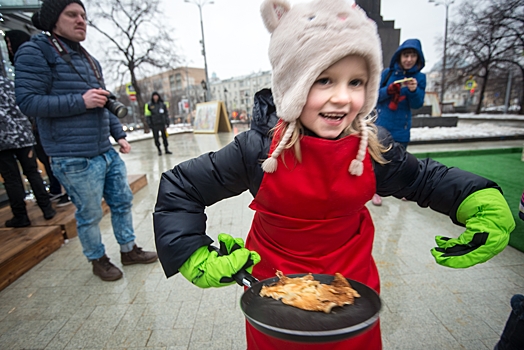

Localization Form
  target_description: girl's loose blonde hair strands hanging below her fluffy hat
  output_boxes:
[272,111,389,164]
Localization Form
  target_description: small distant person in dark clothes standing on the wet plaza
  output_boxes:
[144,91,173,156]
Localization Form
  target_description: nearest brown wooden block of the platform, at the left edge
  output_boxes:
[0,226,64,290]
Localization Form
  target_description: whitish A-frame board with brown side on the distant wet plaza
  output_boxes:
[193,101,231,134]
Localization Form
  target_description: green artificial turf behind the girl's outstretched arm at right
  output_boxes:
[415,148,524,252]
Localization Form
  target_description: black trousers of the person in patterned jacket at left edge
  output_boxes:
[0,147,51,217]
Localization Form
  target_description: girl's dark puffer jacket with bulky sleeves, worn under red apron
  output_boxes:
[153,89,498,277]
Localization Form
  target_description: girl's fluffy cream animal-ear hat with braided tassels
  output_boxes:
[260,0,382,175]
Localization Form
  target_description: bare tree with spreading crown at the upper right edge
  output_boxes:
[448,0,524,114]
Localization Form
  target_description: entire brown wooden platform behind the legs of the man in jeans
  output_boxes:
[0,174,147,290]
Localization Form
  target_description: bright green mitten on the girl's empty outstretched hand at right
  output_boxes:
[431,188,515,268]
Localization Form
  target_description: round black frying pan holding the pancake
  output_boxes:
[233,270,381,343]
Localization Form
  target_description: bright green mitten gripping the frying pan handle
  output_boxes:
[179,233,260,288]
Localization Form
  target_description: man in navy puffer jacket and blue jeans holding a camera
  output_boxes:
[15,0,157,281]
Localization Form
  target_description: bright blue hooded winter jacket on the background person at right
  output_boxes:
[376,39,426,142]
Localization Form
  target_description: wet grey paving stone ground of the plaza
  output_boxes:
[0,126,524,350]
